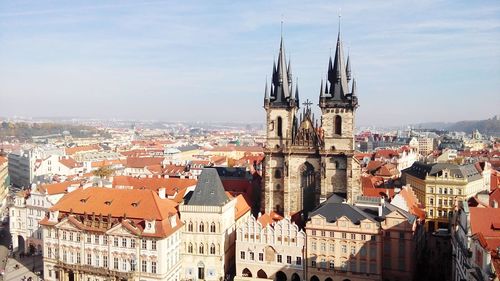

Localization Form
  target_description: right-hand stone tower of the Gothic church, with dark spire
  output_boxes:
[319,27,361,201]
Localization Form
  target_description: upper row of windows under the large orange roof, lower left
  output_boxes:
[52,229,156,250]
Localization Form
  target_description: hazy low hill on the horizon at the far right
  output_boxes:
[412,115,500,136]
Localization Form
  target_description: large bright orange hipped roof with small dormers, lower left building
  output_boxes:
[51,187,177,221]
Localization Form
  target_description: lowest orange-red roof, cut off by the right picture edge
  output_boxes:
[469,207,500,250]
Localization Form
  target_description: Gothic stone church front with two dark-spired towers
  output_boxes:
[261,26,360,216]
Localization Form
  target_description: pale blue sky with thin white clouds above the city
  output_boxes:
[0,0,500,126]
